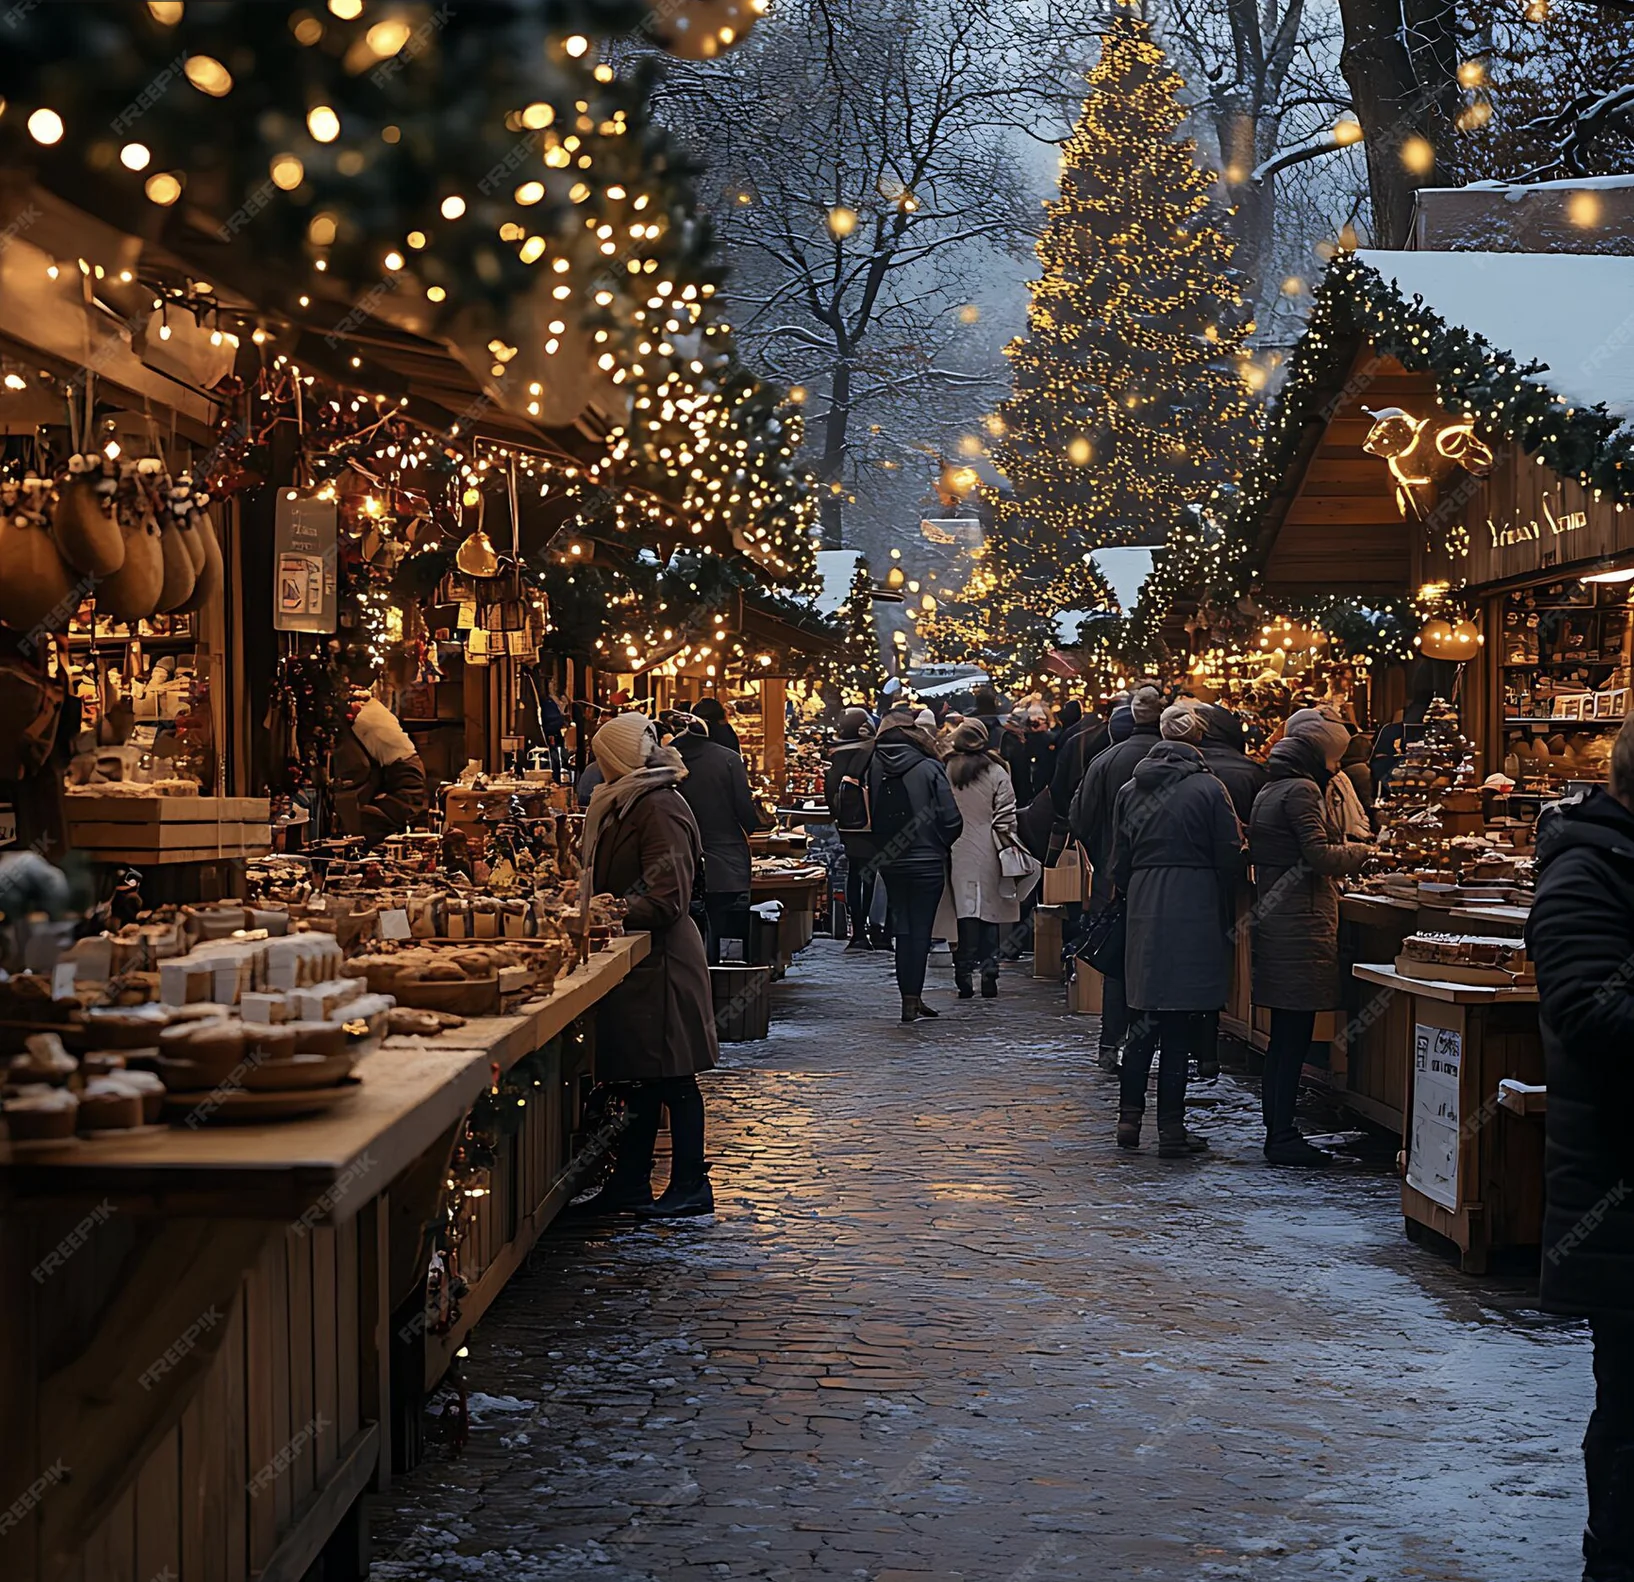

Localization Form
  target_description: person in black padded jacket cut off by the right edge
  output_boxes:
[1526,719,1634,1582]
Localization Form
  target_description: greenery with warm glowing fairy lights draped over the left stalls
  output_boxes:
[0,0,814,683]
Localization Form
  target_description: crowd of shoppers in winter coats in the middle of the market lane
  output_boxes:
[825,683,1374,1167]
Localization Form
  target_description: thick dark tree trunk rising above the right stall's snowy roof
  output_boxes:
[1338,0,1459,247]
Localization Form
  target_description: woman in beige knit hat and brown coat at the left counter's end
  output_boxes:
[580,714,721,1219]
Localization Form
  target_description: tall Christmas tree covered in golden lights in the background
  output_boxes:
[992,8,1253,568]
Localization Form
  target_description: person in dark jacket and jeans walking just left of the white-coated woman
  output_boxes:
[868,709,964,1021]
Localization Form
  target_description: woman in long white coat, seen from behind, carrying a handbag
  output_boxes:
[936,721,1021,1000]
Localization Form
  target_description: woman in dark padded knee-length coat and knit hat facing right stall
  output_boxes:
[1248,708,1374,1167]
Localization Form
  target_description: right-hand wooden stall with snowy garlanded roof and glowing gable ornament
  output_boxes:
[1215,252,1634,1270]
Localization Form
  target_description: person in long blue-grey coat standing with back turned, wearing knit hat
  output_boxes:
[1111,722,1242,1159]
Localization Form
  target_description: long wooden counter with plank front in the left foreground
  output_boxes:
[0,935,649,1582]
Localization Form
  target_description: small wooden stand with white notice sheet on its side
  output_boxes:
[1353,963,1544,1275]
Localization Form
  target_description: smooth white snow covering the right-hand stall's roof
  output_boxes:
[1359,250,1634,421]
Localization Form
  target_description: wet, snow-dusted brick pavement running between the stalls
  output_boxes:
[373,941,1592,1582]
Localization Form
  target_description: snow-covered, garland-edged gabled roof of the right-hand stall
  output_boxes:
[1201,252,1634,601]
